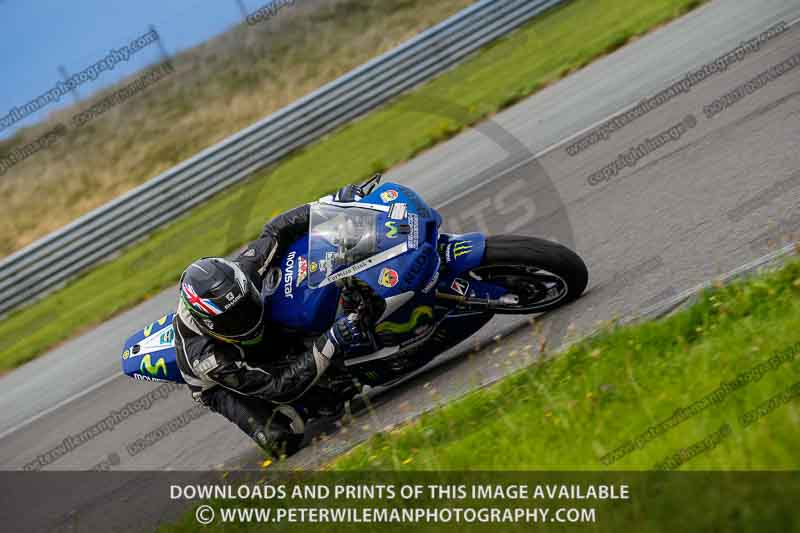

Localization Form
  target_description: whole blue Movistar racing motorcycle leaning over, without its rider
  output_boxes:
[122,175,588,436]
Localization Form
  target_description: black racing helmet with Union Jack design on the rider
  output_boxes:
[179,257,264,344]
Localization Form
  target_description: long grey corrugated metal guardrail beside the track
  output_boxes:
[0,0,563,313]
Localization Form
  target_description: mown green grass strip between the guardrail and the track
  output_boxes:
[0,0,698,371]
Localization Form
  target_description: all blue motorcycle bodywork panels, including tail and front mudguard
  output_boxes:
[122,183,505,383]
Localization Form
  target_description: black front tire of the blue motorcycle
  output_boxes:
[470,235,589,315]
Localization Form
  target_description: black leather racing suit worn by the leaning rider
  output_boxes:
[175,205,340,453]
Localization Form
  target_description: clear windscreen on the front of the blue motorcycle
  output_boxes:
[308,204,380,289]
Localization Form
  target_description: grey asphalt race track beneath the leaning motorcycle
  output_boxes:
[0,0,800,529]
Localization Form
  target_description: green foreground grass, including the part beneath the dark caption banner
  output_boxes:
[159,260,800,533]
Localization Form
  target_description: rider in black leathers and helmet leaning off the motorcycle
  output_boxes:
[175,186,372,455]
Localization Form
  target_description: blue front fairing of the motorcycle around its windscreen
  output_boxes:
[272,183,441,344]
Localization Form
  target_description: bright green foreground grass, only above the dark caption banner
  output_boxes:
[331,261,800,470]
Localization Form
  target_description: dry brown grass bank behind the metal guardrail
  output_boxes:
[0,0,473,257]
